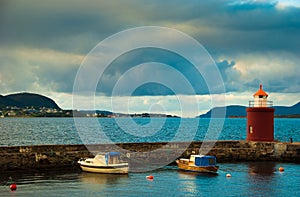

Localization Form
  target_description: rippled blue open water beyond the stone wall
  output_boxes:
[0,118,300,146]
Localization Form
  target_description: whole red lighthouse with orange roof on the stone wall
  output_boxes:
[246,85,275,142]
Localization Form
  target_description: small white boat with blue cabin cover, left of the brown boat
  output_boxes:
[78,152,129,174]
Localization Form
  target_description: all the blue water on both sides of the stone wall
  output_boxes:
[0,118,300,197]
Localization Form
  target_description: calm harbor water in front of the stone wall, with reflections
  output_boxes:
[0,162,300,197]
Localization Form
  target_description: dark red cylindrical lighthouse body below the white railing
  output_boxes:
[246,107,275,142]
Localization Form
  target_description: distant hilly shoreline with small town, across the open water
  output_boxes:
[0,92,300,118]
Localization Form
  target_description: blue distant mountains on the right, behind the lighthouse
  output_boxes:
[198,102,300,118]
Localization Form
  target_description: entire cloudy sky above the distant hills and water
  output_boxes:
[0,0,300,117]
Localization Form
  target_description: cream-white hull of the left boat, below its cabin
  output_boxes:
[79,164,129,174]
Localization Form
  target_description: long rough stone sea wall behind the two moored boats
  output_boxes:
[0,141,300,171]
